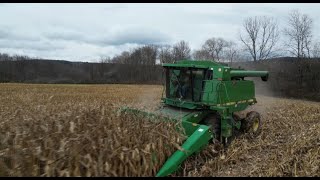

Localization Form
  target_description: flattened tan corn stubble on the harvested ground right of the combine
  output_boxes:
[176,96,320,177]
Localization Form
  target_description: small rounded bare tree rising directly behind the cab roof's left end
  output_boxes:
[173,41,191,61]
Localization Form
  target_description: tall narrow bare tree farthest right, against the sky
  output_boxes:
[284,10,313,58]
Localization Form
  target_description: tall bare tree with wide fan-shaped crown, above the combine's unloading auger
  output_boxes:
[240,16,279,61]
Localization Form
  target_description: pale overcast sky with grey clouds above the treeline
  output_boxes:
[0,3,320,62]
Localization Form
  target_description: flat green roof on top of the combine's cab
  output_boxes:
[162,60,228,69]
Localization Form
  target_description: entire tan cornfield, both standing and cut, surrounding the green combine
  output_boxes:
[0,84,320,176]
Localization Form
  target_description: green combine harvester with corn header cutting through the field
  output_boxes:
[121,60,269,177]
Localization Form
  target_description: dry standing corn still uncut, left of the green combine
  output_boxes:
[0,85,184,176]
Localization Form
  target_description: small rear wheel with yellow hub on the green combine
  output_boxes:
[241,111,261,138]
